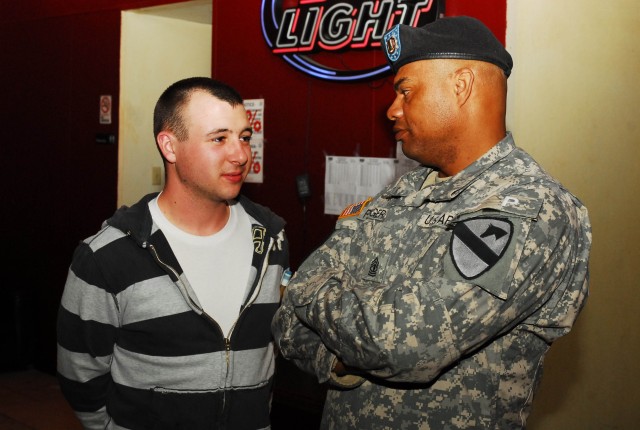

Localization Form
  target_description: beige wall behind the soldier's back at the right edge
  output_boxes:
[506,0,640,430]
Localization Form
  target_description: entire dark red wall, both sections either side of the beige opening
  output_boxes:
[0,0,506,370]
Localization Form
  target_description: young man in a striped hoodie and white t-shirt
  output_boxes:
[58,78,288,430]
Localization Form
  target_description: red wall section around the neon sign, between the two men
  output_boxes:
[213,0,506,268]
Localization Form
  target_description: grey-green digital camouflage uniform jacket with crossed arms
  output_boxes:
[272,134,591,430]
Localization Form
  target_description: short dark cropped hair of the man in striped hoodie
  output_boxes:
[153,77,242,140]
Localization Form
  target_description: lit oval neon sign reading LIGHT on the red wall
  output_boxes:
[261,0,444,82]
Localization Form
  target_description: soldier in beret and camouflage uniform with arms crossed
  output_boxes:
[272,17,591,430]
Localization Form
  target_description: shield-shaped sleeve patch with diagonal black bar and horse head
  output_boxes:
[451,218,513,279]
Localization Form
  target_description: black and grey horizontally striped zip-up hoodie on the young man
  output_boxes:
[58,195,288,430]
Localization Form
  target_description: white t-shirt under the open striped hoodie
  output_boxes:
[149,198,253,336]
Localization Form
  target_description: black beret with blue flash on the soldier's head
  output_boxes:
[382,16,513,77]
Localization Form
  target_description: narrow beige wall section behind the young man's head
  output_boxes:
[118,1,211,206]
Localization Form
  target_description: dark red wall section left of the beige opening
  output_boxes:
[0,0,185,371]
